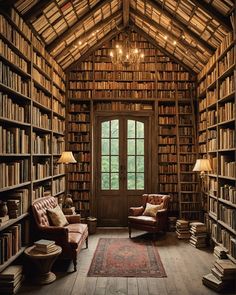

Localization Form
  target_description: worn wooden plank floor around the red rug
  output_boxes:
[19,228,233,295]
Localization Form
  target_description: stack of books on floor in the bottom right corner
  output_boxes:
[202,259,236,292]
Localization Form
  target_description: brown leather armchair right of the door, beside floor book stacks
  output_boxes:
[128,194,170,238]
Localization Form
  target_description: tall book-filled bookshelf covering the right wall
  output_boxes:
[198,33,236,262]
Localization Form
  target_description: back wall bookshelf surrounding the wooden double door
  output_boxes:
[67,32,198,219]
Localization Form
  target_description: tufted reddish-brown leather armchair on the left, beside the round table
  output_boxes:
[32,196,88,271]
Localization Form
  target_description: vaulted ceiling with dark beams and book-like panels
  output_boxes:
[8,0,235,73]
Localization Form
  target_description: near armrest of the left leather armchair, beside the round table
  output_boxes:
[38,226,69,243]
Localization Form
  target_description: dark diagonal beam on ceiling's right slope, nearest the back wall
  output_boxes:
[130,8,206,64]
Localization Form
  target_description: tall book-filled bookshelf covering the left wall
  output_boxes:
[0,10,65,271]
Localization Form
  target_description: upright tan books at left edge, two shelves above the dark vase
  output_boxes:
[0,126,29,154]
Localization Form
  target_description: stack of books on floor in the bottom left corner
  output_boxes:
[0,265,24,294]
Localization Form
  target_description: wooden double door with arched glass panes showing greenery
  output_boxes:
[95,116,148,226]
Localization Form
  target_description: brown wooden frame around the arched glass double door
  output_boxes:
[91,111,155,225]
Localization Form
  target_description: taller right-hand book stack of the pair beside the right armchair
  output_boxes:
[189,222,207,248]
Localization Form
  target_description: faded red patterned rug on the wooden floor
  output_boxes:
[88,238,166,278]
